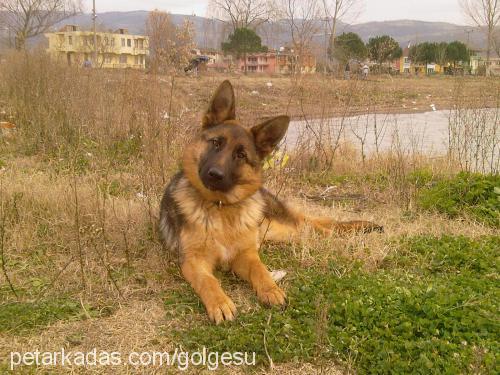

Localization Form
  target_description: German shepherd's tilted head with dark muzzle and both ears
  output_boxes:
[183,81,290,204]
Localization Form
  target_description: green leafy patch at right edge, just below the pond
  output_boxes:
[418,173,500,227]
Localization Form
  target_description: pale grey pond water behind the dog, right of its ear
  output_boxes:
[285,108,500,162]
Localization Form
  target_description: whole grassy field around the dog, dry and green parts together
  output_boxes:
[0,55,500,374]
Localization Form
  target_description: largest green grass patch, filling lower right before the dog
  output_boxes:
[171,237,500,374]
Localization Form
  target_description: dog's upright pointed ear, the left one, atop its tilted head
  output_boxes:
[202,80,236,129]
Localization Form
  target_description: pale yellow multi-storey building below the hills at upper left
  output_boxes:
[45,25,149,69]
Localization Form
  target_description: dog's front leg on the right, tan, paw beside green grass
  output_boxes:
[231,249,286,305]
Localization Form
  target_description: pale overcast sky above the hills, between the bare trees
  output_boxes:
[84,0,465,24]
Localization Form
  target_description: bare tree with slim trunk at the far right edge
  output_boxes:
[460,0,500,75]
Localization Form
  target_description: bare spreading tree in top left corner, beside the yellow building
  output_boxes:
[0,0,82,50]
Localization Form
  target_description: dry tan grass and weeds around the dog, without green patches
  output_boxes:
[0,52,493,374]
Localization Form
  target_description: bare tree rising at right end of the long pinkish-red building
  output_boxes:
[276,0,321,71]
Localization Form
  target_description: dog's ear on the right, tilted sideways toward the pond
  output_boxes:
[251,116,290,159]
